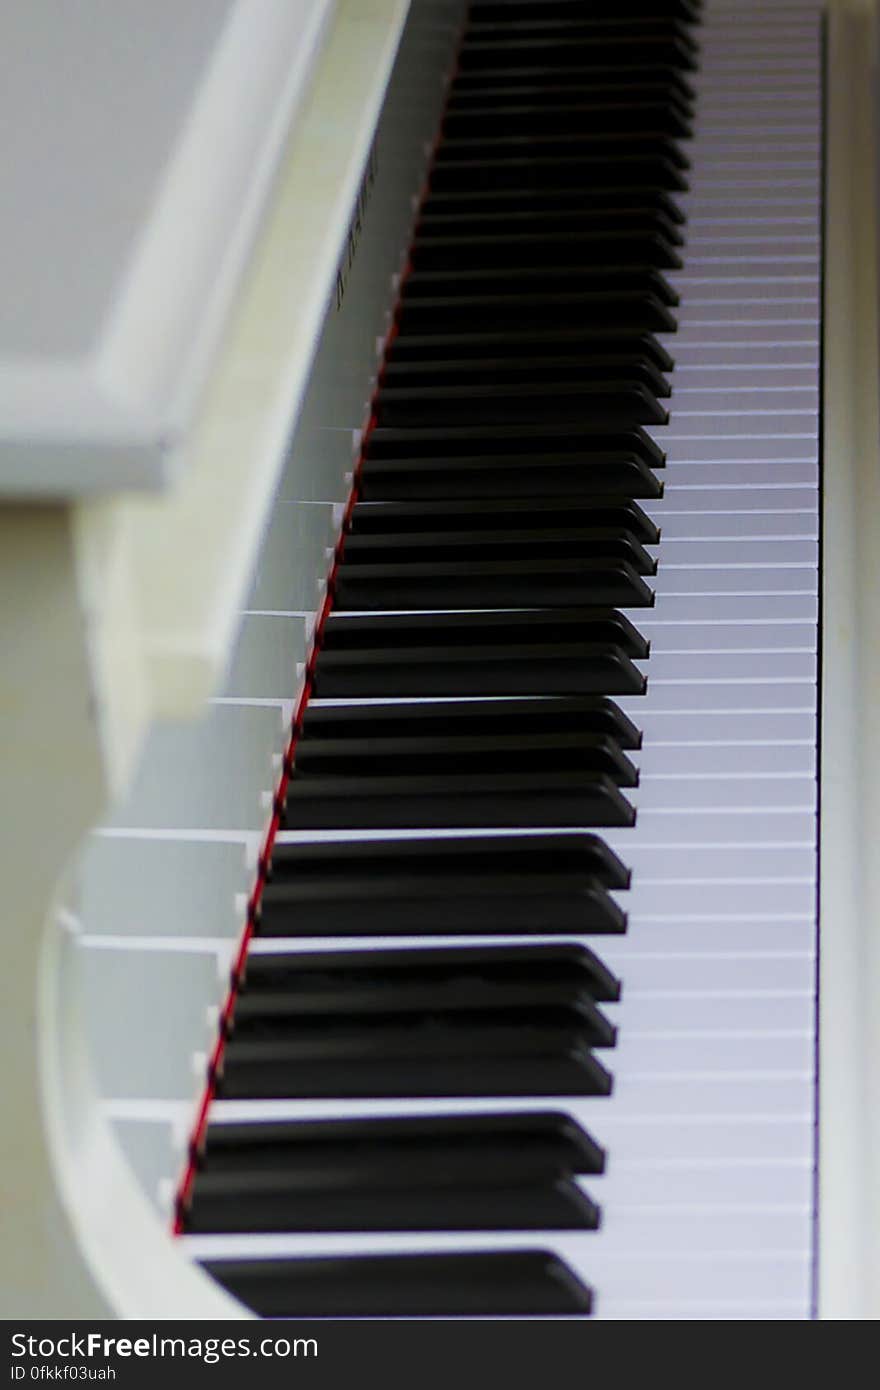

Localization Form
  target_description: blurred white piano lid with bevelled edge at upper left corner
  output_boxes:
[0,0,335,498]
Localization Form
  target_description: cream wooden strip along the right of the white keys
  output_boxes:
[817,0,880,1321]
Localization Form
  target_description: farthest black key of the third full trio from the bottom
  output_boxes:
[348,496,660,542]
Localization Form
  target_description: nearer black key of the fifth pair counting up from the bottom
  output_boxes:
[398,286,676,334]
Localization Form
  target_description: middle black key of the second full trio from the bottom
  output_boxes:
[293,730,638,787]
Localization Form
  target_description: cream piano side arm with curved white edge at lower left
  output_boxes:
[0,507,246,1318]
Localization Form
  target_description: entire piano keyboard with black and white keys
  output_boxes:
[178,0,822,1319]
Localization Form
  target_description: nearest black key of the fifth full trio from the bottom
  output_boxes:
[410,227,681,271]
